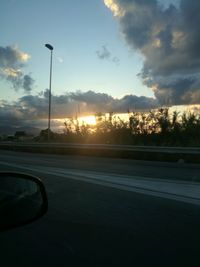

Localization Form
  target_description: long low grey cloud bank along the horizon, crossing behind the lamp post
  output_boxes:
[0,89,158,132]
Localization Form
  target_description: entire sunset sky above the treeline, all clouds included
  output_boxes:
[0,0,200,133]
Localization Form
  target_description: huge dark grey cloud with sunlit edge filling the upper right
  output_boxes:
[104,0,200,105]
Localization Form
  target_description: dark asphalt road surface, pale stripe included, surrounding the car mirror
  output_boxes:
[0,150,200,266]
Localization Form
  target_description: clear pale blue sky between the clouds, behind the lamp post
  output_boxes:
[0,0,148,99]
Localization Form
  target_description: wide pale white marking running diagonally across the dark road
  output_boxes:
[0,161,200,205]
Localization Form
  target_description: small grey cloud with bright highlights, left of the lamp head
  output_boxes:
[0,46,34,92]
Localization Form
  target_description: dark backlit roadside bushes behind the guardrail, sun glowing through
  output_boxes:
[37,108,200,147]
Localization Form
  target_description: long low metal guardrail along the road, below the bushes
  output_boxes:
[0,142,200,163]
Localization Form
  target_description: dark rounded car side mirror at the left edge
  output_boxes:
[0,172,48,231]
